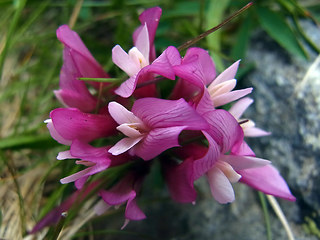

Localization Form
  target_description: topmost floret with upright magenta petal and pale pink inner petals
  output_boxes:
[112,7,181,98]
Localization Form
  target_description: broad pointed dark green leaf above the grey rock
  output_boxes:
[257,7,308,59]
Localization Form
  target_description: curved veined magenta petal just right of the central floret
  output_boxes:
[203,109,243,154]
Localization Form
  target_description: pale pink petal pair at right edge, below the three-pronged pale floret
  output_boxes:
[229,98,271,137]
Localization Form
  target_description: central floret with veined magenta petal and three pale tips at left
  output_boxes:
[109,98,208,160]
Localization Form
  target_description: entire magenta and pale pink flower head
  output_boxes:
[46,7,295,229]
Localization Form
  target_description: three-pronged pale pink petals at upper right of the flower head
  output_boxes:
[208,60,252,107]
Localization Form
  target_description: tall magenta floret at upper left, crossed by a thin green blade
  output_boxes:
[54,25,109,112]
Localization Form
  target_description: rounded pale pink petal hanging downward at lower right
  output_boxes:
[207,167,235,204]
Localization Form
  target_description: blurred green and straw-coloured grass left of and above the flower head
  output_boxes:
[0,0,319,239]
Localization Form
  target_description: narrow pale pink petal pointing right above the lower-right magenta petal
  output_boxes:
[219,155,271,171]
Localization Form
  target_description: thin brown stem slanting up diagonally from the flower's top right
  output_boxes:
[178,2,253,51]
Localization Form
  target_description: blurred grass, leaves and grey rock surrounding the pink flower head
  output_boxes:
[0,0,320,240]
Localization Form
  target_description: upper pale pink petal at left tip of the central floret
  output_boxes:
[108,102,142,125]
